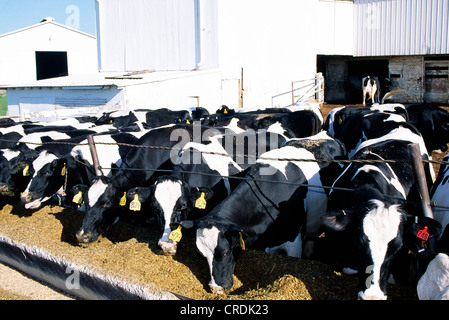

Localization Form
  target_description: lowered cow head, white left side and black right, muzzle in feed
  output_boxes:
[193,220,247,294]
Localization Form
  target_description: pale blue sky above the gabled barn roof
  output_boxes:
[0,0,95,35]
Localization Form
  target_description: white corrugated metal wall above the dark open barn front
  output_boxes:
[354,0,449,56]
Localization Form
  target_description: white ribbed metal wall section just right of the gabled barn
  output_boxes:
[97,0,217,71]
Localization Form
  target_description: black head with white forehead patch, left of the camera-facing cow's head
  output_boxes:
[76,176,123,245]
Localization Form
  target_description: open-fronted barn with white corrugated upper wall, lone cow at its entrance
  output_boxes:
[318,0,449,104]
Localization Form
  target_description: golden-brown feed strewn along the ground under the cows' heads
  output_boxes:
[0,202,416,300]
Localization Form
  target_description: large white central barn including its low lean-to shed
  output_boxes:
[6,0,353,119]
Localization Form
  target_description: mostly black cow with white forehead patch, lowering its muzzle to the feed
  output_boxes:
[76,124,231,245]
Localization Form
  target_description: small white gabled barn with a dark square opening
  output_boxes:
[0,18,98,86]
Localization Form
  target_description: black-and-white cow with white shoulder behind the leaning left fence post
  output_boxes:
[21,133,137,209]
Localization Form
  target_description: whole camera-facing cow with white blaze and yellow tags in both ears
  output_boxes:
[127,130,285,255]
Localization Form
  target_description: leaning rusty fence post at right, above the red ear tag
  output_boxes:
[410,143,433,219]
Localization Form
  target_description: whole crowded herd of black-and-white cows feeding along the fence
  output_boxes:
[0,104,449,299]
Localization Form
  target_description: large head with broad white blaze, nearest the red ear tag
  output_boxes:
[322,200,405,300]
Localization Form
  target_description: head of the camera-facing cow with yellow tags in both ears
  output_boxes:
[127,176,213,255]
